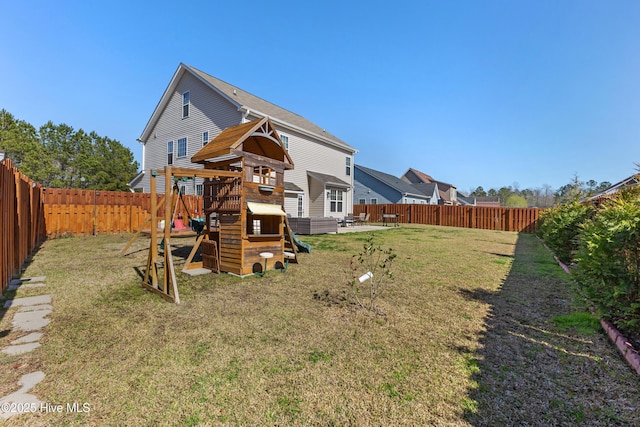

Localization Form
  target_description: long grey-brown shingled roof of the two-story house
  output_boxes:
[138,63,357,153]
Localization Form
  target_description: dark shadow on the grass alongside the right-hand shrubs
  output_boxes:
[462,234,640,426]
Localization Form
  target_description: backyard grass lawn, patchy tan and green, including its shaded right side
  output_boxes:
[0,226,640,426]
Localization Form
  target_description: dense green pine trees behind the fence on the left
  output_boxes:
[0,108,139,191]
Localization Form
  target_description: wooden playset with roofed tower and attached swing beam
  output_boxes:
[142,118,298,303]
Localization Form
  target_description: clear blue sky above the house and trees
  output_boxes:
[0,0,640,191]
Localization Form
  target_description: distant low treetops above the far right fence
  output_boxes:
[470,175,611,208]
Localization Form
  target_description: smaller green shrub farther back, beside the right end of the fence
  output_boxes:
[538,201,594,264]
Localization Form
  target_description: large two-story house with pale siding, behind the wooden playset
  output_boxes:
[129,64,356,218]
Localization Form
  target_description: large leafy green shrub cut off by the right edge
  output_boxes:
[572,188,640,330]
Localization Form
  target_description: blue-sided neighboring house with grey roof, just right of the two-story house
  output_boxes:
[353,165,438,205]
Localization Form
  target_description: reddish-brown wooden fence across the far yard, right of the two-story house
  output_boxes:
[353,204,542,233]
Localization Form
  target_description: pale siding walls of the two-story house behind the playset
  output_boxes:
[136,67,355,222]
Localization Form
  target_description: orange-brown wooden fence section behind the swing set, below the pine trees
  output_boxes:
[44,188,202,236]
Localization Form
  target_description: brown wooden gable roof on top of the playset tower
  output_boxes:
[191,117,293,168]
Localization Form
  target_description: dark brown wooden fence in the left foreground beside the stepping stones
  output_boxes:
[0,159,46,291]
